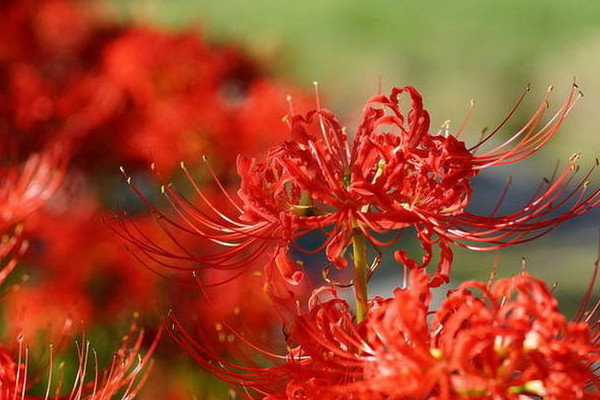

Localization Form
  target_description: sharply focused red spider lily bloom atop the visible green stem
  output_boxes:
[239,87,600,286]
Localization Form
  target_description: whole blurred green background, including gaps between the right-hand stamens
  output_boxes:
[109,0,600,311]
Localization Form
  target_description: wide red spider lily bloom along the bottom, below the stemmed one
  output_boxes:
[173,270,600,400]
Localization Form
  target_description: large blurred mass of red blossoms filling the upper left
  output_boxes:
[0,0,312,173]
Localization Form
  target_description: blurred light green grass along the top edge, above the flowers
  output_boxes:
[108,0,600,123]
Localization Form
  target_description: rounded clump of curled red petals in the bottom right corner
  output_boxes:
[431,273,600,399]
